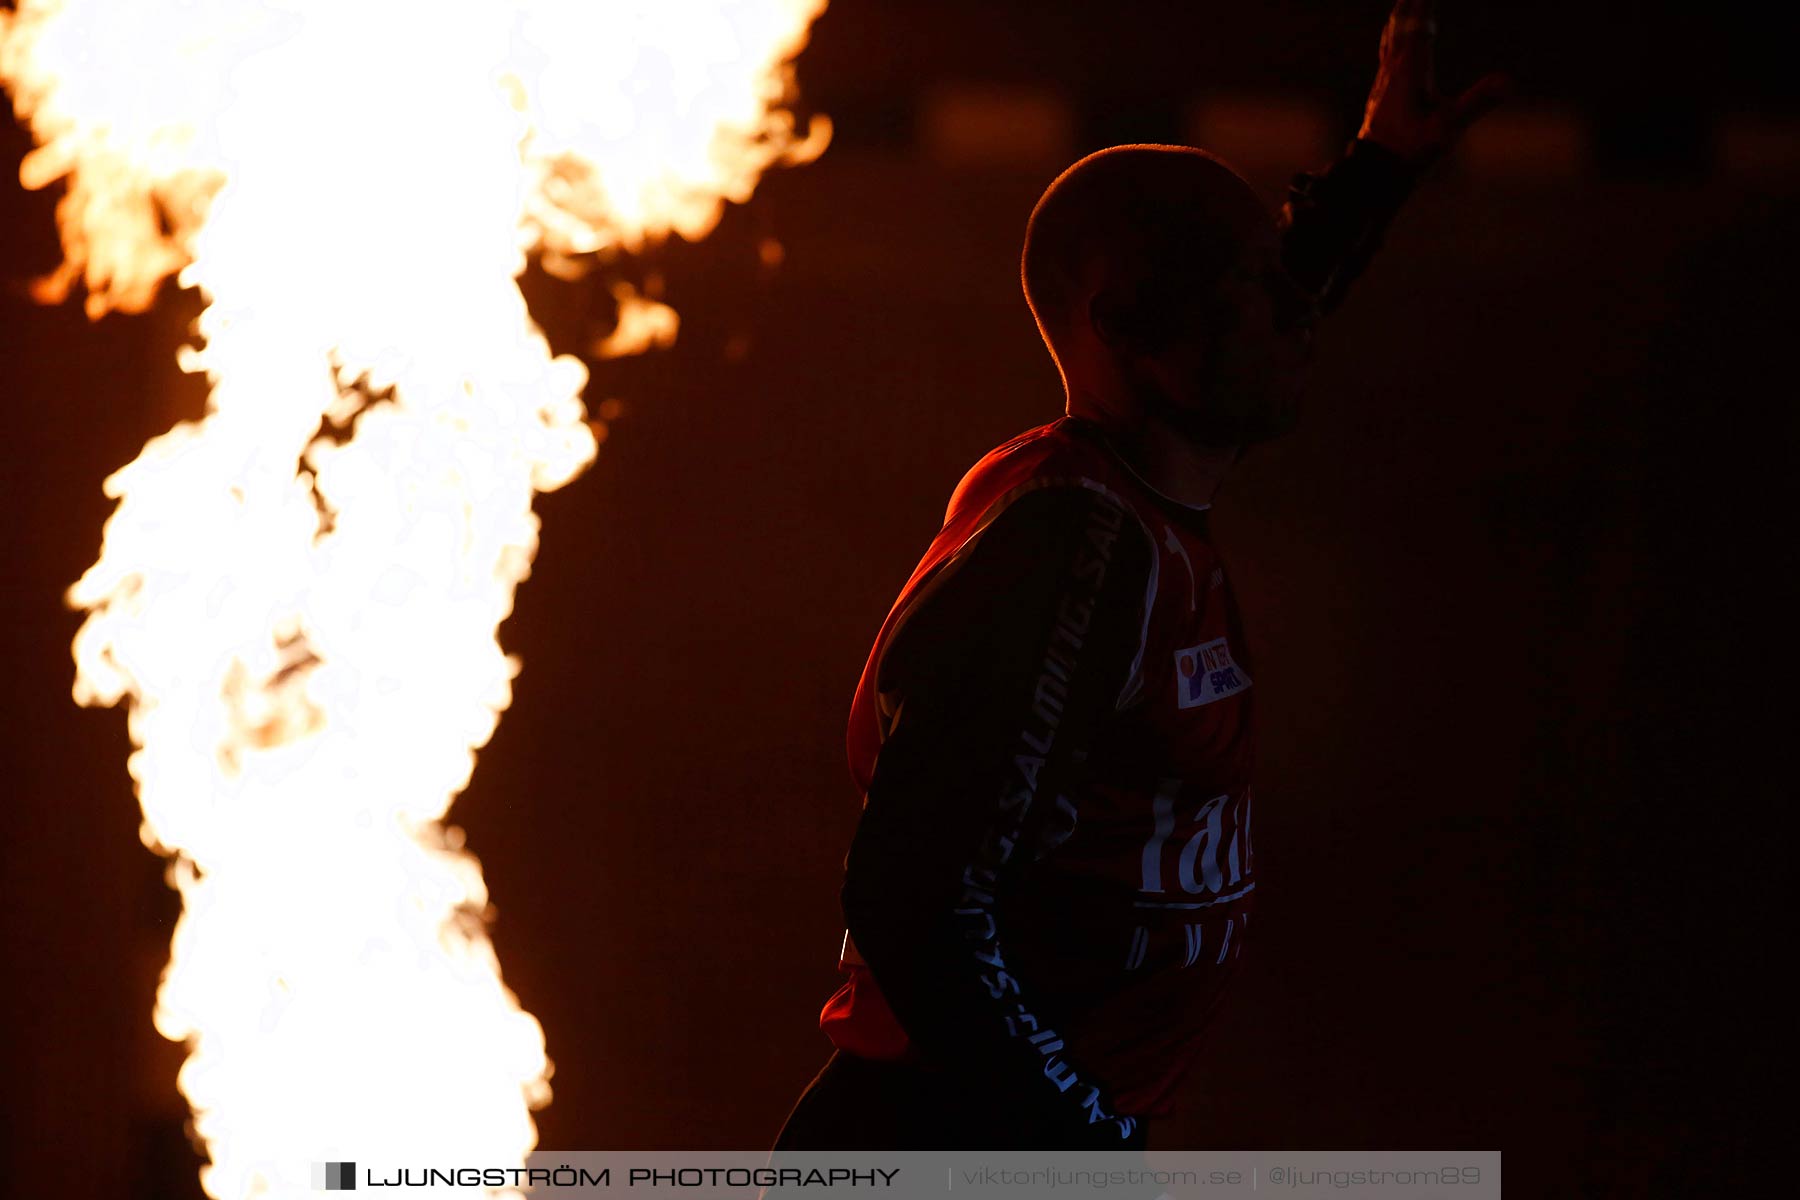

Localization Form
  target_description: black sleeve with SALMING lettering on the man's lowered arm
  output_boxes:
[842,482,1150,1146]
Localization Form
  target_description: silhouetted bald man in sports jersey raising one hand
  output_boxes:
[776,0,1505,1151]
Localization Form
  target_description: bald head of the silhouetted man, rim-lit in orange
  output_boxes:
[1021,146,1271,363]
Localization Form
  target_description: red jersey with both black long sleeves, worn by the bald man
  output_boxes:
[821,142,1411,1146]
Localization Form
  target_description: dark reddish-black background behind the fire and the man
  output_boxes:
[0,0,1800,1196]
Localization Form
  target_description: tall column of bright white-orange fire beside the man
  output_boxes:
[0,0,830,1200]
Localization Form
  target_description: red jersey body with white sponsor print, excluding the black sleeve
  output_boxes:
[821,417,1256,1115]
